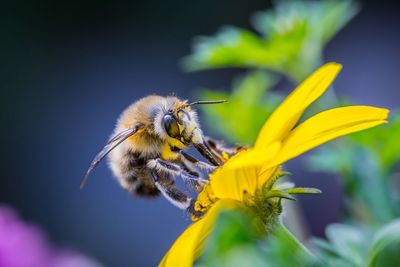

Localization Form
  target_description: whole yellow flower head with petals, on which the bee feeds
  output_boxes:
[160,63,389,267]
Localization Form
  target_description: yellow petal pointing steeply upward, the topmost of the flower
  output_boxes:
[255,63,342,149]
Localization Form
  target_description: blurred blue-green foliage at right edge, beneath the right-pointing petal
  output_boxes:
[308,113,400,224]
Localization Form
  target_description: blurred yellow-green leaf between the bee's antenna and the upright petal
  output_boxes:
[201,71,283,145]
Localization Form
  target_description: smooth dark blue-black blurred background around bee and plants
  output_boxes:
[0,0,400,266]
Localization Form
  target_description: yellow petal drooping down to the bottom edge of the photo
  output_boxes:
[159,200,240,267]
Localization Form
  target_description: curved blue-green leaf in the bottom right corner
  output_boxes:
[368,219,400,267]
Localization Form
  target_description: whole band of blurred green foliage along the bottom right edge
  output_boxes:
[196,211,400,267]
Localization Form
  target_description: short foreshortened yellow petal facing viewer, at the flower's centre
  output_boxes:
[210,143,280,201]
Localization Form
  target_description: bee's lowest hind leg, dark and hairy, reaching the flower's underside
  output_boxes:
[151,172,203,217]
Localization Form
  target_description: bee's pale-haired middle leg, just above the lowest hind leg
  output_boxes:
[147,158,208,186]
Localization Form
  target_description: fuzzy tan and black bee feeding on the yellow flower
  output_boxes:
[80,95,236,216]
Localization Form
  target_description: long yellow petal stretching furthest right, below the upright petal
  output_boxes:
[270,106,389,166]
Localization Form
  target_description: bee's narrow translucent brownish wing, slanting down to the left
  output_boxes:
[80,126,140,189]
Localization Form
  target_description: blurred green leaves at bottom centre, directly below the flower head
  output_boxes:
[196,211,322,267]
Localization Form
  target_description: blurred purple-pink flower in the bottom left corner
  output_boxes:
[0,205,101,267]
